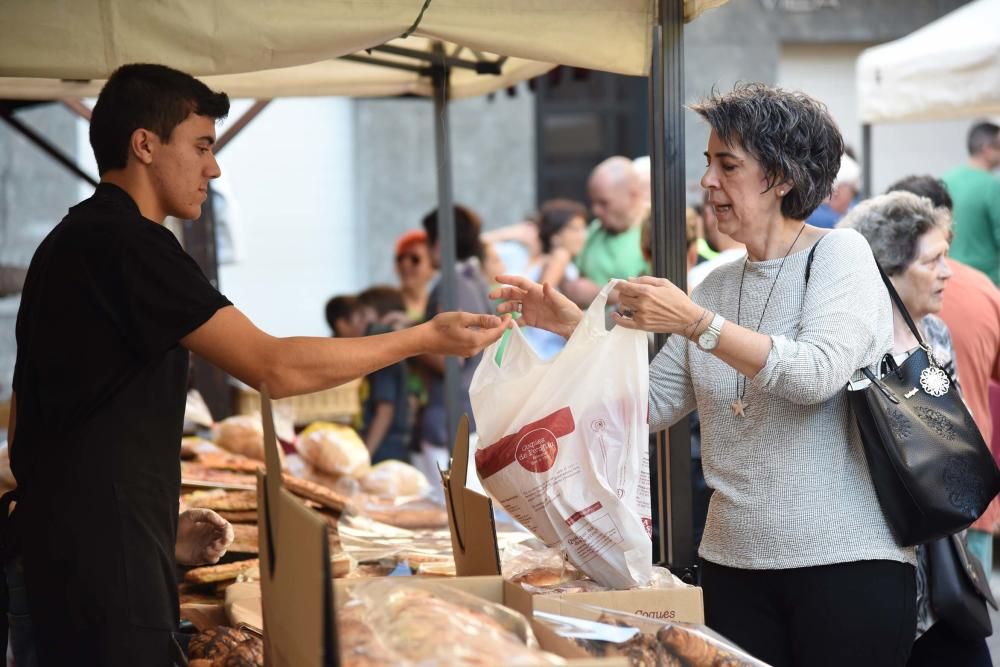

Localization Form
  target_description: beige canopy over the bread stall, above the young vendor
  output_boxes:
[0,0,725,85]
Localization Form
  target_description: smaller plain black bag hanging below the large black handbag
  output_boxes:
[925,535,998,639]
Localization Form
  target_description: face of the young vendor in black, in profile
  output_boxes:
[150,113,222,220]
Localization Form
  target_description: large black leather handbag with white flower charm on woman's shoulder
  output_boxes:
[847,267,1000,546]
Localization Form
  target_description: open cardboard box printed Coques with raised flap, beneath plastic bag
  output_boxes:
[441,416,705,623]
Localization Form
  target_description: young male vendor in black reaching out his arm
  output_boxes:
[3,65,507,667]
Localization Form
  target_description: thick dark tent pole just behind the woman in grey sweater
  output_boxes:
[649,0,694,578]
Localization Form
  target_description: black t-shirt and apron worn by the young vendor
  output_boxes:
[11,183,231,665]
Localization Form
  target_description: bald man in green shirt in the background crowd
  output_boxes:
[577,156,649,286]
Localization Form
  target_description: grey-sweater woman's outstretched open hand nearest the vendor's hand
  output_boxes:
[490,276,583,338]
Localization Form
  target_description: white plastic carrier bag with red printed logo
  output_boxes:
[469,281,652,589]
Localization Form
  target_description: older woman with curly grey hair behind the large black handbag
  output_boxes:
[837,191,991,667]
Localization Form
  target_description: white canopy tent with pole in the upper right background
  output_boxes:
[856,0,1000,193]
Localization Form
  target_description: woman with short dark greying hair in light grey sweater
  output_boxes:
[498,84,916,667]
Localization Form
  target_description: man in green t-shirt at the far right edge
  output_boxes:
[943,122,1000,285]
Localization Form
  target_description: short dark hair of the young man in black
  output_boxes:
[90,64,229,174]
